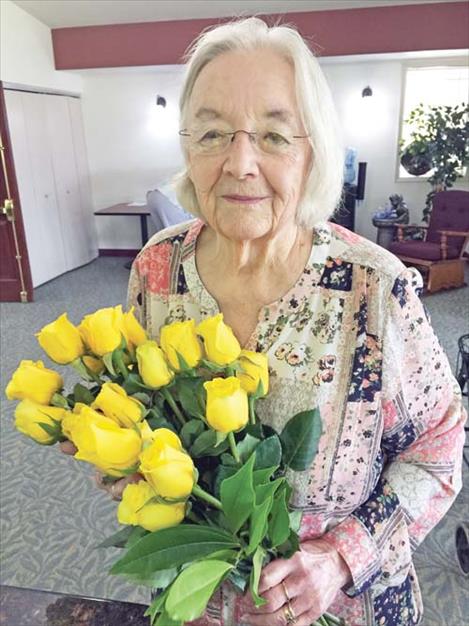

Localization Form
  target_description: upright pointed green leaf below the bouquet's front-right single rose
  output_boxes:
[220,452,256,533]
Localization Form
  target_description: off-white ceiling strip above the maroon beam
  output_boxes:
[13,0,466,28]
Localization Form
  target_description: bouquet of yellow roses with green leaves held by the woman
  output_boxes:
[6,306,340,626]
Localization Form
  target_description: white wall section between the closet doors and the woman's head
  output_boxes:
[82,66,184,248]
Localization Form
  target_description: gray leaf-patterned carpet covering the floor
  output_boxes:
[0,257,469,626]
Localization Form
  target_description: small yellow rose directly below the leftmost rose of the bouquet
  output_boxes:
[15,400,67,445]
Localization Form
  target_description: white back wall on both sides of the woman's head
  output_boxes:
[78,56,469,248]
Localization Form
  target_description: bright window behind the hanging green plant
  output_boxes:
[397,65,469,180]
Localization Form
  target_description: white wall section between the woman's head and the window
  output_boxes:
[322,60,469,241]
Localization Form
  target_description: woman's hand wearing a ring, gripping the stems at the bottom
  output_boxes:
[241,539,352,626]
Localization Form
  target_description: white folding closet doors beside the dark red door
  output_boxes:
[5,90,97,287]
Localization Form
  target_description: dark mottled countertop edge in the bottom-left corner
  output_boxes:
[0,585,150,626]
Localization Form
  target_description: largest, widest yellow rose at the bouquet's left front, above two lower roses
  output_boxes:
[62,406,142,476]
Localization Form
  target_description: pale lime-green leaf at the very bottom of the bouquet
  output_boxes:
[165,560,233,621]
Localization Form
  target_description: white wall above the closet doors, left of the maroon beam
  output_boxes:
[0,0,82,93]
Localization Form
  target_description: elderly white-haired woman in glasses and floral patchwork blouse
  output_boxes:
[110,18,464,626]
